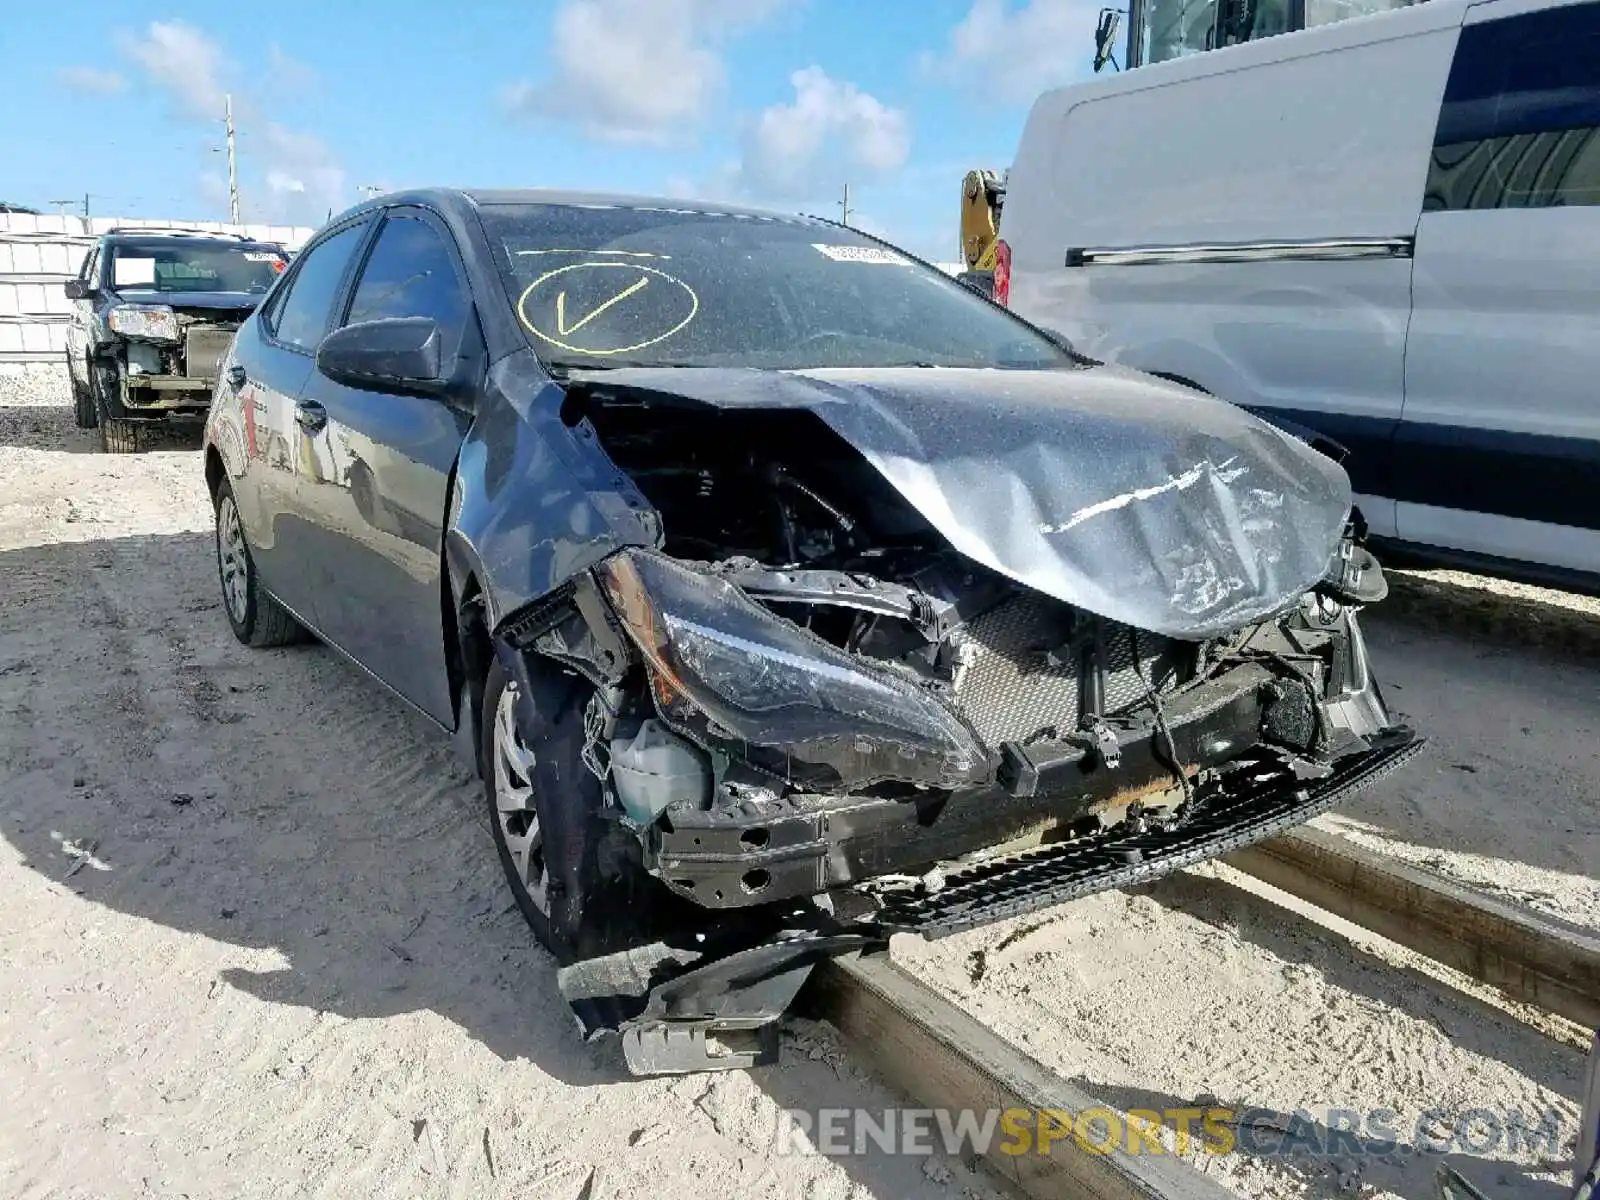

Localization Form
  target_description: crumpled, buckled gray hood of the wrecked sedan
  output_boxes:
[571,366,1350,640]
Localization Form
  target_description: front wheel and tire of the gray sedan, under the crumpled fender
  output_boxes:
[482,661,651,965]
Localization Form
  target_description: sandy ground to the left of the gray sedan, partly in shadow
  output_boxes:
[0,376,1000,1200]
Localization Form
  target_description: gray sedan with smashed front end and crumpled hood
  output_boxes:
[205,190,1419,1074]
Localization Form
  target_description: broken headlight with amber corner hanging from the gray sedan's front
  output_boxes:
[598,550,989,800]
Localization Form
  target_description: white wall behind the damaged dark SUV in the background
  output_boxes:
[0,213,317,365]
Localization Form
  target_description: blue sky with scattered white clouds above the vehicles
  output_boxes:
[0,0,1099,259]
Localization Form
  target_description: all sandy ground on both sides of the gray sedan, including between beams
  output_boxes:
[0,366,1600,1200]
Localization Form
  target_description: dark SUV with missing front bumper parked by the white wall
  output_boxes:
[66,229,288,454]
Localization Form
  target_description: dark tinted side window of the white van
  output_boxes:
[1422,3,1600,213]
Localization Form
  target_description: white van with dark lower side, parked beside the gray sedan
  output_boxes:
[1002,0,1600,587]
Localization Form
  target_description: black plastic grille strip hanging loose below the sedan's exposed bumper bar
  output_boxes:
[875,728,1424,938]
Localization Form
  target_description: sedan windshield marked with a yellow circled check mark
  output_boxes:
[483,205,1074,370]
